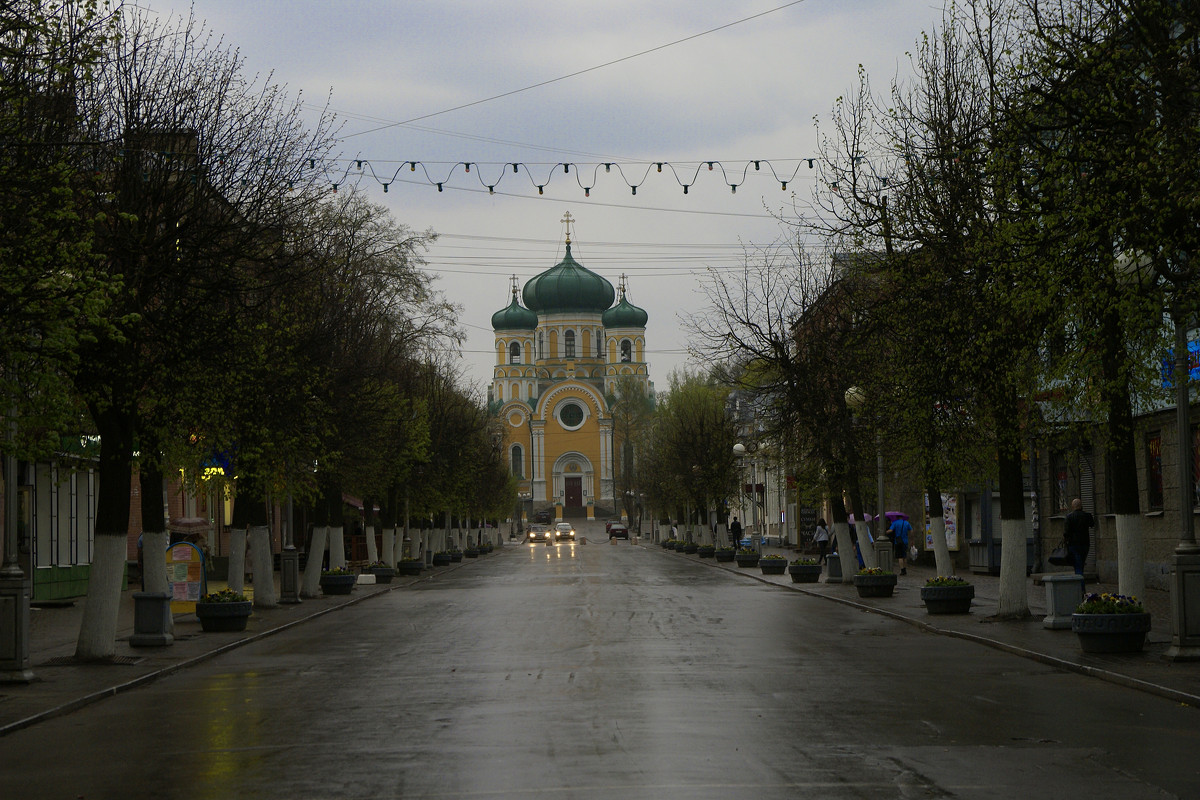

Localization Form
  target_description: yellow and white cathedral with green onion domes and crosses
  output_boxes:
[490,213,653,519]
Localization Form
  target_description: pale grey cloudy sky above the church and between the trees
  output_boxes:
[138,0,941,390]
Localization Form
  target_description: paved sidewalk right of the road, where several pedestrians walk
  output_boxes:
[696,545,1200,708]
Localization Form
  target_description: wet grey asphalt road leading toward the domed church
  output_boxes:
[0,527,1200,800]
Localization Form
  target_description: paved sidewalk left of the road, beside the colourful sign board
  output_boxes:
[0,561,465,738]
